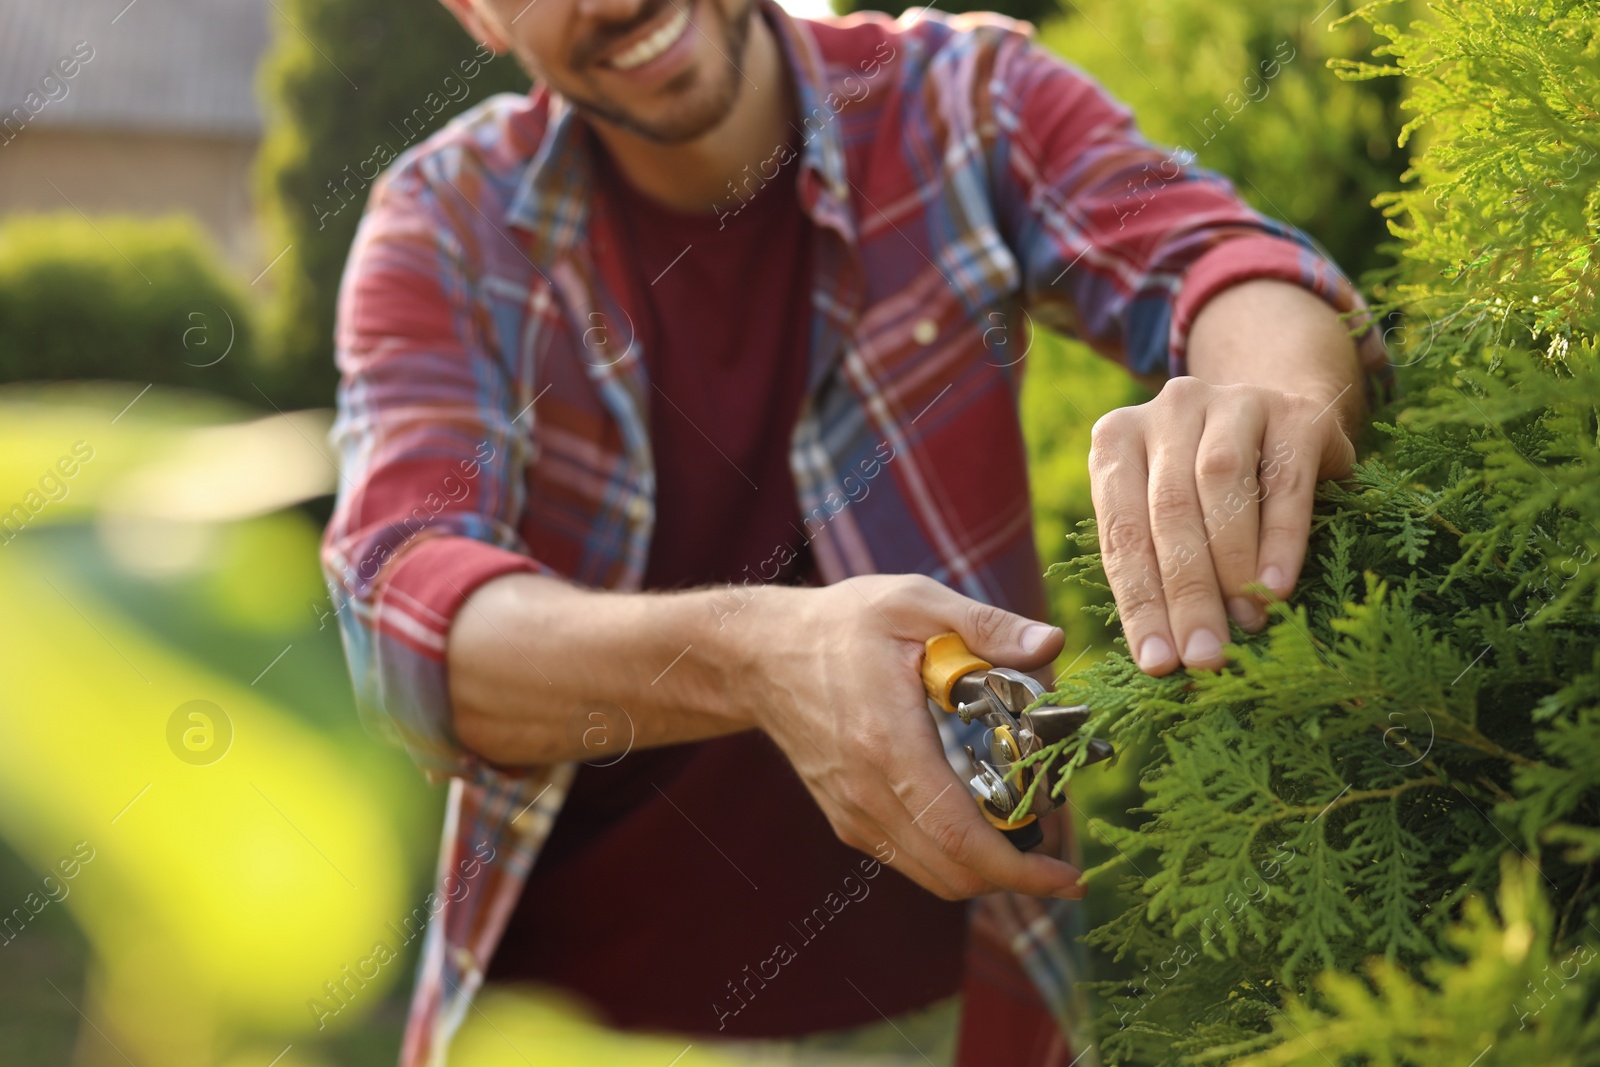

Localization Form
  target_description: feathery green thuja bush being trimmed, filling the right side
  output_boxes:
[1024,0,1600,1067]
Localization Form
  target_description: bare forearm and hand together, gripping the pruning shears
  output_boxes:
[448,574,1078,899]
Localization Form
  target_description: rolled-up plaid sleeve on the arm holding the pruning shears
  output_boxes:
[322,168,554,779]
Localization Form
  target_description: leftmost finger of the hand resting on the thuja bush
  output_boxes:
[1090,408,1178,675]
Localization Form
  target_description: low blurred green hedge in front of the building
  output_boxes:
[0,214,262,403]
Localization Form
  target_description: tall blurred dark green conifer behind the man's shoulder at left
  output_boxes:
[258,0,528,406]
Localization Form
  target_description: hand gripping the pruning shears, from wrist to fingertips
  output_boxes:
[723,574,1082,901]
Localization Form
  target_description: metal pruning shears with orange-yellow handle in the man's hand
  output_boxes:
[922,633,1114,853]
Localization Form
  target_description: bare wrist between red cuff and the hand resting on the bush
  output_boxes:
[1189,280,1365,434]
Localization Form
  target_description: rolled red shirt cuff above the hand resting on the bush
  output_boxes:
[1171,235,1394,403]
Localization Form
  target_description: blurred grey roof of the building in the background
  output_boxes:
[0,0,270,136]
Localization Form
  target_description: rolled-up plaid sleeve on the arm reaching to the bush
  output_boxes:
[986,34,1390,396]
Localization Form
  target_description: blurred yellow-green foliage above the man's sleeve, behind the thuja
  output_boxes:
[1043,0,1406,275]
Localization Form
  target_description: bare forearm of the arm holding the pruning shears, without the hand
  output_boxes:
[446,574,752,765]
